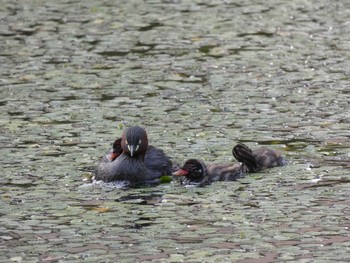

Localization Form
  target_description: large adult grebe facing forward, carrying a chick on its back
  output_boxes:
[95,126,172,185]
